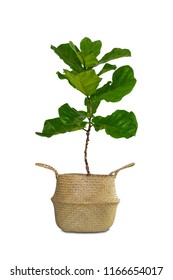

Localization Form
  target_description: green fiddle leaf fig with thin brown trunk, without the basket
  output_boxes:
[36,37,138,175]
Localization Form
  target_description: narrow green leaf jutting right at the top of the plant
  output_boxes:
[99,48,131,64]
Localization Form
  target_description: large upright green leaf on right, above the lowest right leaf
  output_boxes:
[93,65,136,102]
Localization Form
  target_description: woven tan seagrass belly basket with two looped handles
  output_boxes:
[36,163,134,232]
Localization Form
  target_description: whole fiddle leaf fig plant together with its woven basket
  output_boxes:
[36,37,137,232]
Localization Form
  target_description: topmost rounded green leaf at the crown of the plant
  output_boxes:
[80,37,102,57]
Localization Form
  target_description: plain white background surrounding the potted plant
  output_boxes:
[0,0,173,280]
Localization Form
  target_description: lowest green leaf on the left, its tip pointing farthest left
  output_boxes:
[36,118,86,137]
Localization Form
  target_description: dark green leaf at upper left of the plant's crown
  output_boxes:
[51,44,83,72]
